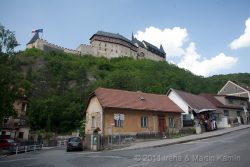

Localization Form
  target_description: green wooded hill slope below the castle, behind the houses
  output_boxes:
[12,49,250,132]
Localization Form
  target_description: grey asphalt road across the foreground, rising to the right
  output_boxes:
[0,129,250,167]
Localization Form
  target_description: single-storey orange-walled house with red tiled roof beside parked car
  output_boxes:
[85,88,183,149]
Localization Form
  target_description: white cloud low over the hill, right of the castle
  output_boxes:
[177,42,238,76]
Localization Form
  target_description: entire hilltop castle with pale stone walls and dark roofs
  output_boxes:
[26,31,166,61]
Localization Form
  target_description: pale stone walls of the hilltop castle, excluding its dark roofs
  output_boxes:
[27,32,165,61]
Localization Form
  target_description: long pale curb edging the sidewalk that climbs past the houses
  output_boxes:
[112,126,250,151]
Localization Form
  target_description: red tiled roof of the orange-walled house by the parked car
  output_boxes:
[94,88,183,113]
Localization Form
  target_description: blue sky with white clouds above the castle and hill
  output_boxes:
[0,0,250,77]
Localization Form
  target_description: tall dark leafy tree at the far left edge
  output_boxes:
[0,24,18,122]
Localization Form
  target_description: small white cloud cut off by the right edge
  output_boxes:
[229,18,250,49]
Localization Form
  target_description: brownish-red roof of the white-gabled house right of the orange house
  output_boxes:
[172,89,216,110]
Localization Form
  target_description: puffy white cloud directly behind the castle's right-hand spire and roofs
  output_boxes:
[135,26,188,57]
